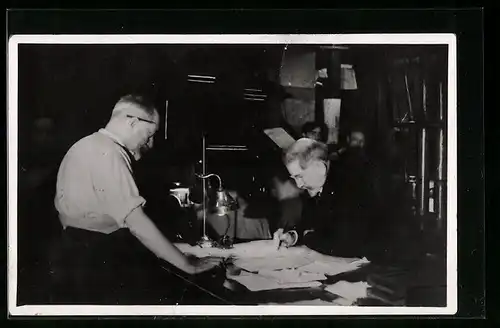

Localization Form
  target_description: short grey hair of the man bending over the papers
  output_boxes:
[283,138,328,168]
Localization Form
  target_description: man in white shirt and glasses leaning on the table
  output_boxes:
[54,95,221,302]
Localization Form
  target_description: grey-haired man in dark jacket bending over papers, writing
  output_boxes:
[274,138,373,257]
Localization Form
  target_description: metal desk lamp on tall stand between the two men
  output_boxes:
[196,136,238,247]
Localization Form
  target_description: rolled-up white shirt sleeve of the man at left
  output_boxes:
[94,147,146,228]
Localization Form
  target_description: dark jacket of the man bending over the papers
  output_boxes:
[294,150,377,257]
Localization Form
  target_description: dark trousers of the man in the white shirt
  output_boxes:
[52,228,182,304]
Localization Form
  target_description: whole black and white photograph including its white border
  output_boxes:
[8,33,457,316]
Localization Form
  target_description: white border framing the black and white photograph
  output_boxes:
[7,33,458,316]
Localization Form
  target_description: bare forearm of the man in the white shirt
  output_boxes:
[126,208,191,273]
